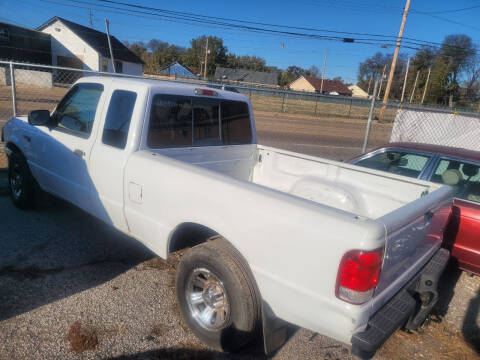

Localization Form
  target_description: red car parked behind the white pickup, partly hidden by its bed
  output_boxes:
[350,143,480,276]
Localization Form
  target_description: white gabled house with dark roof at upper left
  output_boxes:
[37,16,143,75]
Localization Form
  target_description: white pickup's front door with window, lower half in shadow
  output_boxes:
[33,83,104,212]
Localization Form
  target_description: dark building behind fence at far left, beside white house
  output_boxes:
[0,22,52,88]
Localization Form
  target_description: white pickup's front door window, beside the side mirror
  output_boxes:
[53,84,103,136]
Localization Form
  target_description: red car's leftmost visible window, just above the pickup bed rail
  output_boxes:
[355,151,430,178]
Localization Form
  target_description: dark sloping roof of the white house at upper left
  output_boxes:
[37,16,143,64]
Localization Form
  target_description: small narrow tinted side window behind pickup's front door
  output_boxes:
[102,90,137,149]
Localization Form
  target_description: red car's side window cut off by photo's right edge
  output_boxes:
[430,159,480,202]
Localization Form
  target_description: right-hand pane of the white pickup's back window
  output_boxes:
[221,100,252,145]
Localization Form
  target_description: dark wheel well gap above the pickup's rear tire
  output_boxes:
[168,222,219,254]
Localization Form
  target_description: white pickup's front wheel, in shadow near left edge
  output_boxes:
[8,152,35,209]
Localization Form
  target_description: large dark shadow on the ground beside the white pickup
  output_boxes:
[0,196,154,320]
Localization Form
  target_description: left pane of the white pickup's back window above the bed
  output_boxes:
[147,94,192,149]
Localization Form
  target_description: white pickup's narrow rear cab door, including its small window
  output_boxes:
[90,84,146,232]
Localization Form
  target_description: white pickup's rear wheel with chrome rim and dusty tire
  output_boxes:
[175,237,261,352]
